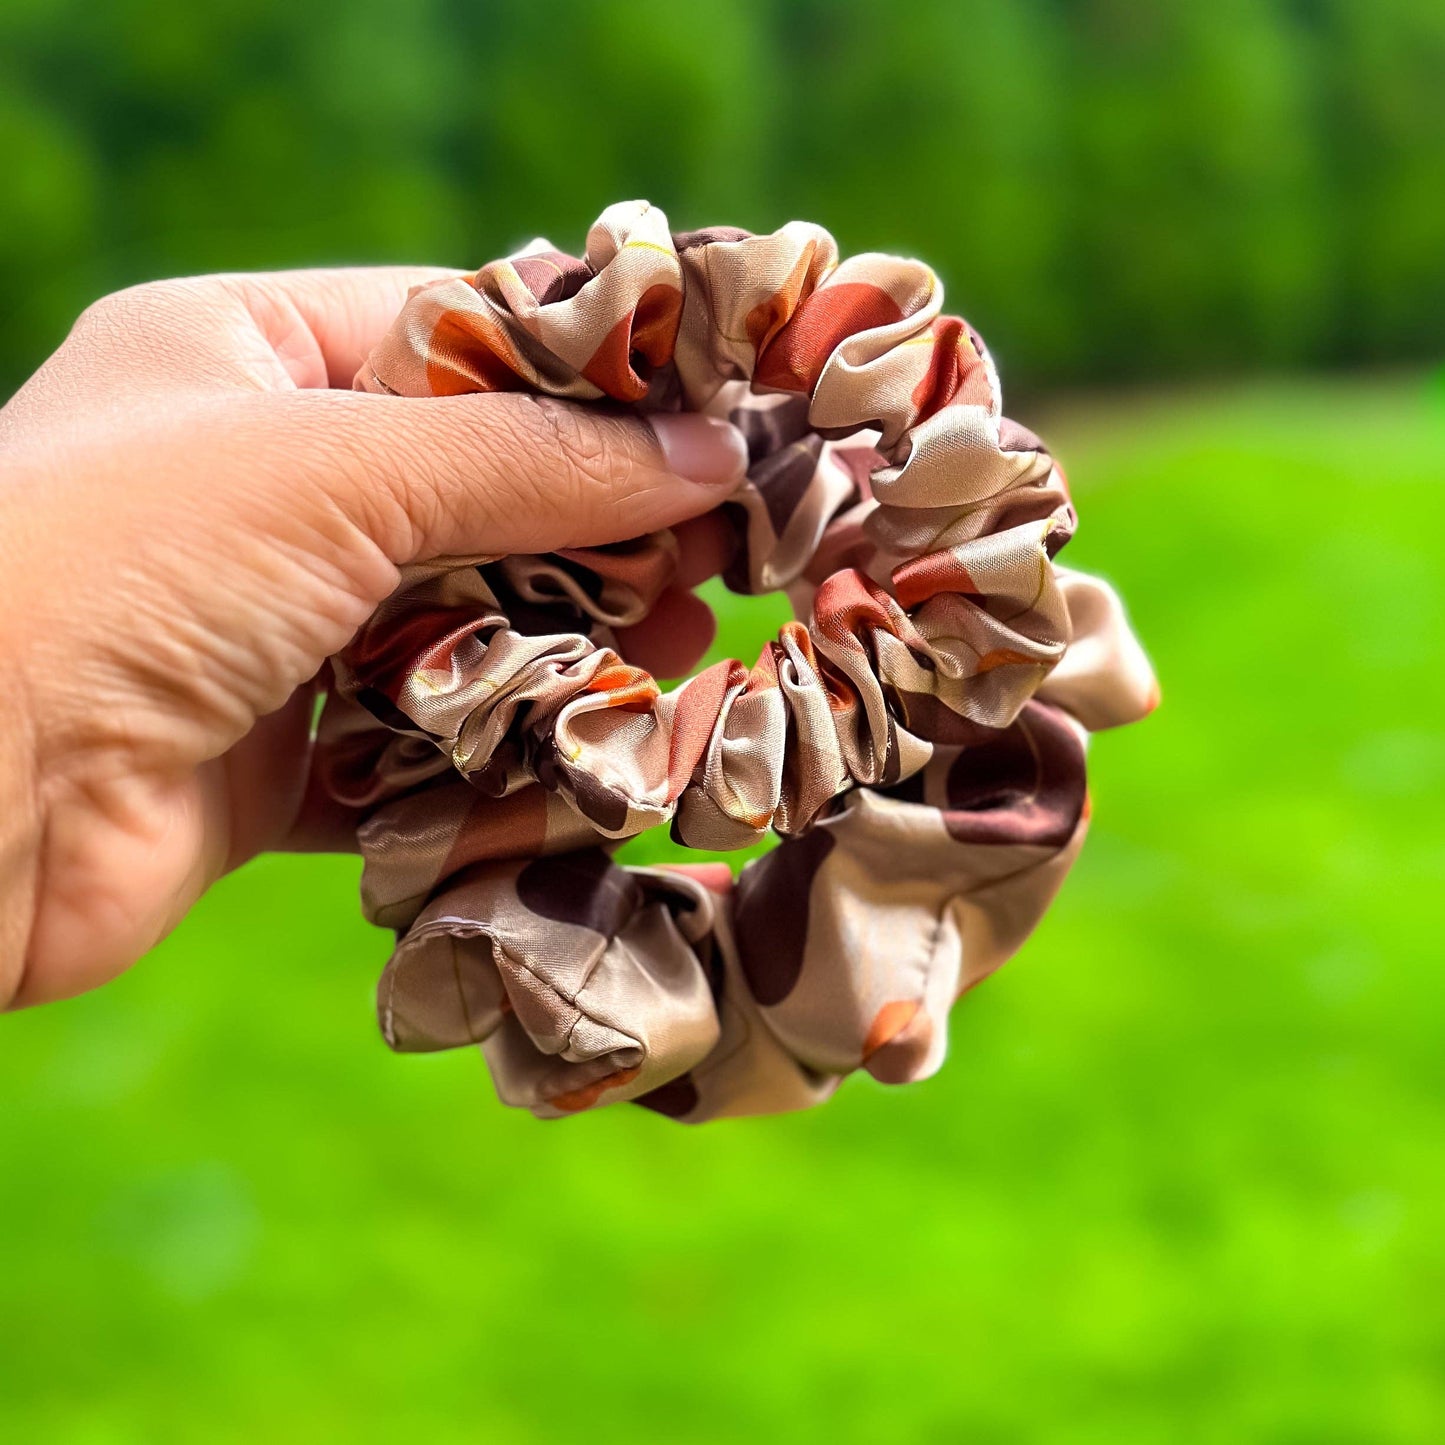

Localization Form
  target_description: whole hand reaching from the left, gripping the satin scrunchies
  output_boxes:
[0,269,746,1006]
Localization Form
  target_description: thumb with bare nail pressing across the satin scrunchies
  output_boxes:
[259,390,747,565]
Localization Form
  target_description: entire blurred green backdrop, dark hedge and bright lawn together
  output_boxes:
[0,0,1445,1445]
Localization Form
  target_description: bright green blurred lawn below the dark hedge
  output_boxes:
[0,379,1445,1445]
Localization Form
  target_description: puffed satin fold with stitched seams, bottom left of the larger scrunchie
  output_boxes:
[379,848,718,1114]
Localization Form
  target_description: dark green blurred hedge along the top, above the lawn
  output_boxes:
[0,0,1445,392]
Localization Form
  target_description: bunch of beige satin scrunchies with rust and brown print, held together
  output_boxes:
[319,202,1156,1121]
